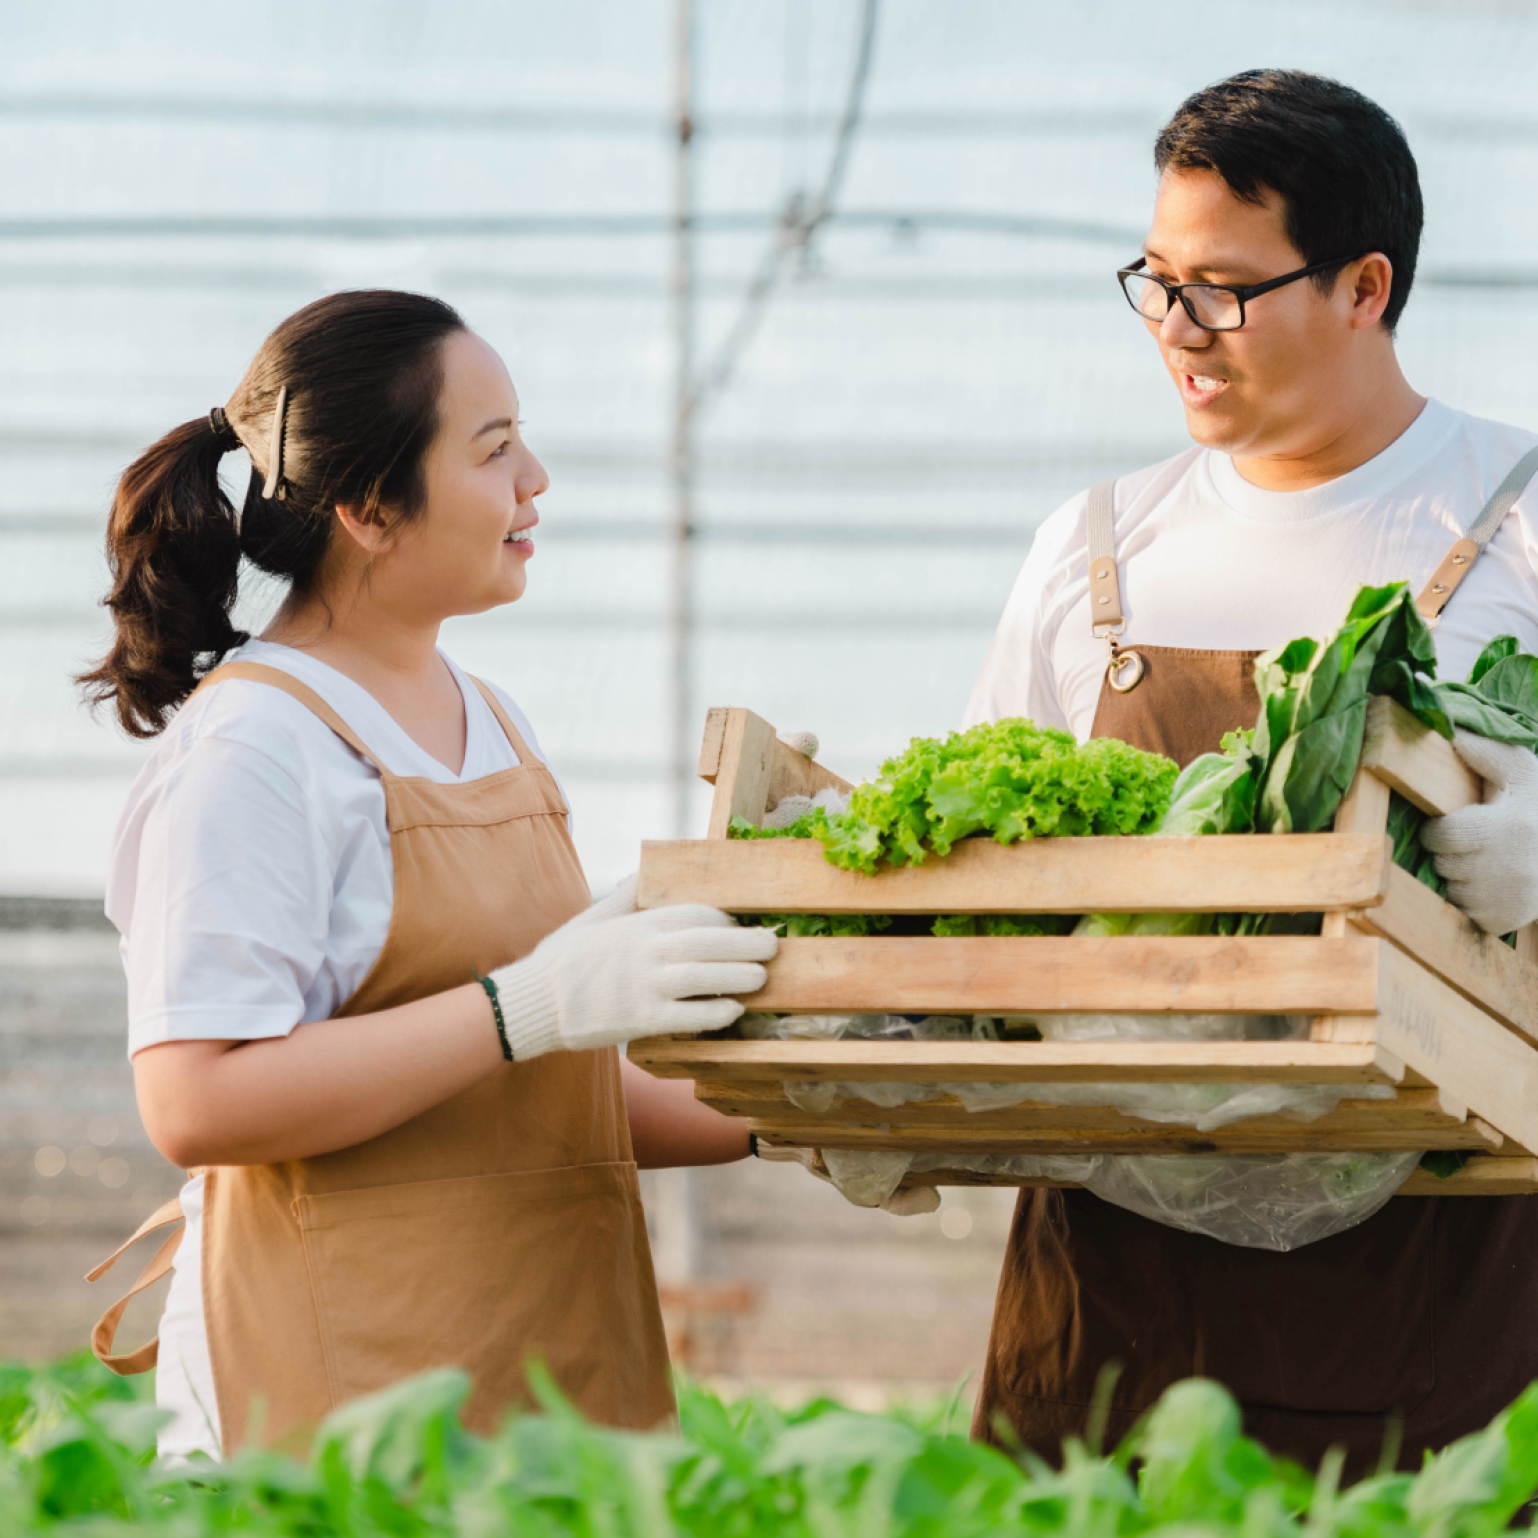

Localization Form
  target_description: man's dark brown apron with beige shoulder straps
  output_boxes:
[974,461,1538,1476]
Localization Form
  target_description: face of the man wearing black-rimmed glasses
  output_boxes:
[1144,171,1381,458]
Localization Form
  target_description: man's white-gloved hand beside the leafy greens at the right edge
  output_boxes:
[1421,732,1538,935]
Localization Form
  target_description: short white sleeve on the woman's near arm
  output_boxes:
[115,735,336,1055]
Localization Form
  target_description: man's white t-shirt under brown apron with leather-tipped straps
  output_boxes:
[966,400,1538,740]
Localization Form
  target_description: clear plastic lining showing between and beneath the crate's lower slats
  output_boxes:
[741,1015,1420,1250]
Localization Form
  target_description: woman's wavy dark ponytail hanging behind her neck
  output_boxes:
[75,417,246,737]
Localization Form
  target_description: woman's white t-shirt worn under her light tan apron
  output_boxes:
[106,641,569,1458]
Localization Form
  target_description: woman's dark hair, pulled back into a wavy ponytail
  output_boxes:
[77,289,464,737]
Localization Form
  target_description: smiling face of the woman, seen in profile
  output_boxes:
[368,331,551,620]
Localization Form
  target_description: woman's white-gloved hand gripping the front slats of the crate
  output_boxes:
[491,877,778,1061]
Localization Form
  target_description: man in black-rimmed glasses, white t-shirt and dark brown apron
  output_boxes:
[967,71,1538,1472]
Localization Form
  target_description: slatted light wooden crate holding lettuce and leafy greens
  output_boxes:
[629,700,1538,1195]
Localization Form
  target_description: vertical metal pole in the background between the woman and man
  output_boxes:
[667,0,695,838]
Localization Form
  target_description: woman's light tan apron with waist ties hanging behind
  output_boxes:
[91,663,674,1452]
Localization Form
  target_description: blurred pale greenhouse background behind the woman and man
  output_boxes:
[0,0,1538,1378]
